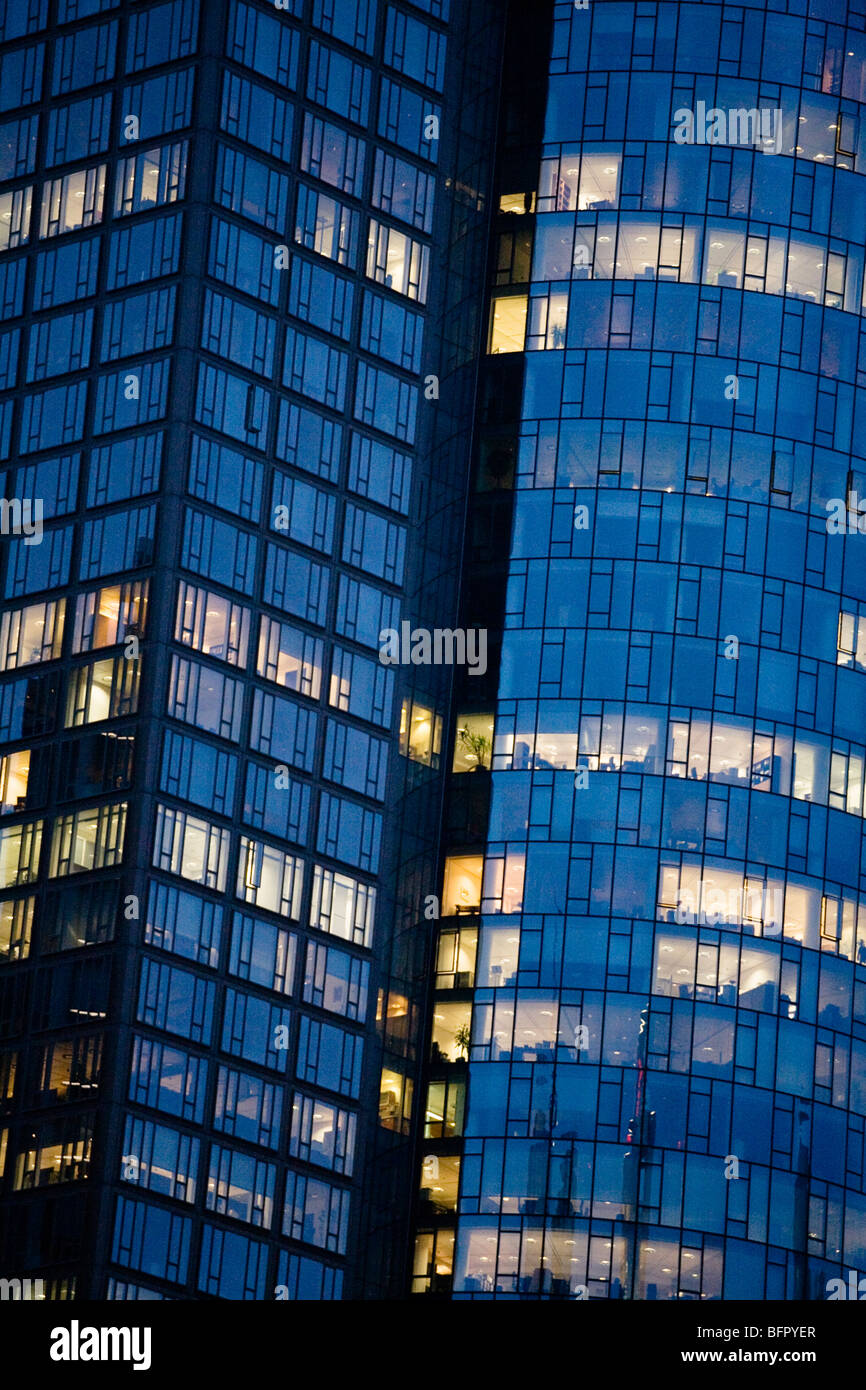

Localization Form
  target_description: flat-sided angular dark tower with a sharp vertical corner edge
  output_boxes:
[0,0,500,1300]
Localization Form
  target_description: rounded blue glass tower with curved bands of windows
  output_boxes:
[444,0,866,1300]
